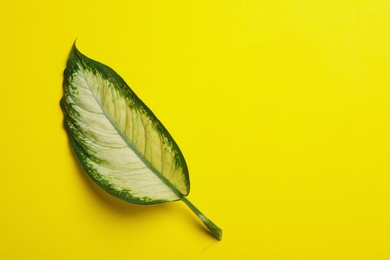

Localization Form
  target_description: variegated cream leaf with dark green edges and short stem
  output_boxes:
[61,42,222,239]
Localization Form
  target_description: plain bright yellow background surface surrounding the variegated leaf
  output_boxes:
[0,0,390,260]
